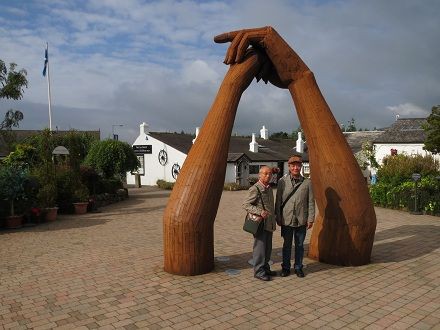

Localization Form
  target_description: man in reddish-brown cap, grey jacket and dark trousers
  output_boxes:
[275,155,315,277]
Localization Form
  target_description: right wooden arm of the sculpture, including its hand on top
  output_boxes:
[214,27,376,266]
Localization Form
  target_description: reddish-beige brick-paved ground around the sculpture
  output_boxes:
[0,188,440,329]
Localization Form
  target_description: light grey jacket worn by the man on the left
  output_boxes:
[243,181,276,231]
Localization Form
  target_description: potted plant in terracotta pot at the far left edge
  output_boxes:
[0,165,28,228]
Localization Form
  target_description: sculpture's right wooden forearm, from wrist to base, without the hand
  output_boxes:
[289,72,376,266]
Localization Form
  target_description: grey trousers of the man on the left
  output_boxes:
[252,228,273,275]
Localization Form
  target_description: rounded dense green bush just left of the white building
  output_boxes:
[84,139,140,179]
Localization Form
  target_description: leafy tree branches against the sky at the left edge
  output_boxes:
[0,60,28,130]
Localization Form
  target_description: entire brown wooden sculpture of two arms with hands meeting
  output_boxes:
[163,27,376,275]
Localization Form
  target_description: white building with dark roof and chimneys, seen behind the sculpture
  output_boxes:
[127,123,309,186]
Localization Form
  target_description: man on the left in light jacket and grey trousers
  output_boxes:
[243,166,277,281]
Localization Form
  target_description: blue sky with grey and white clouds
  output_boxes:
[0,0,440,143]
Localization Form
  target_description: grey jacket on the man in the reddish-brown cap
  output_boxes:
[275,174,315,227]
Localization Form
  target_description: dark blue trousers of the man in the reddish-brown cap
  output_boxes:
[281,225,307,271]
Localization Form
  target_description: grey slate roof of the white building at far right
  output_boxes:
[373,118,426,143]
